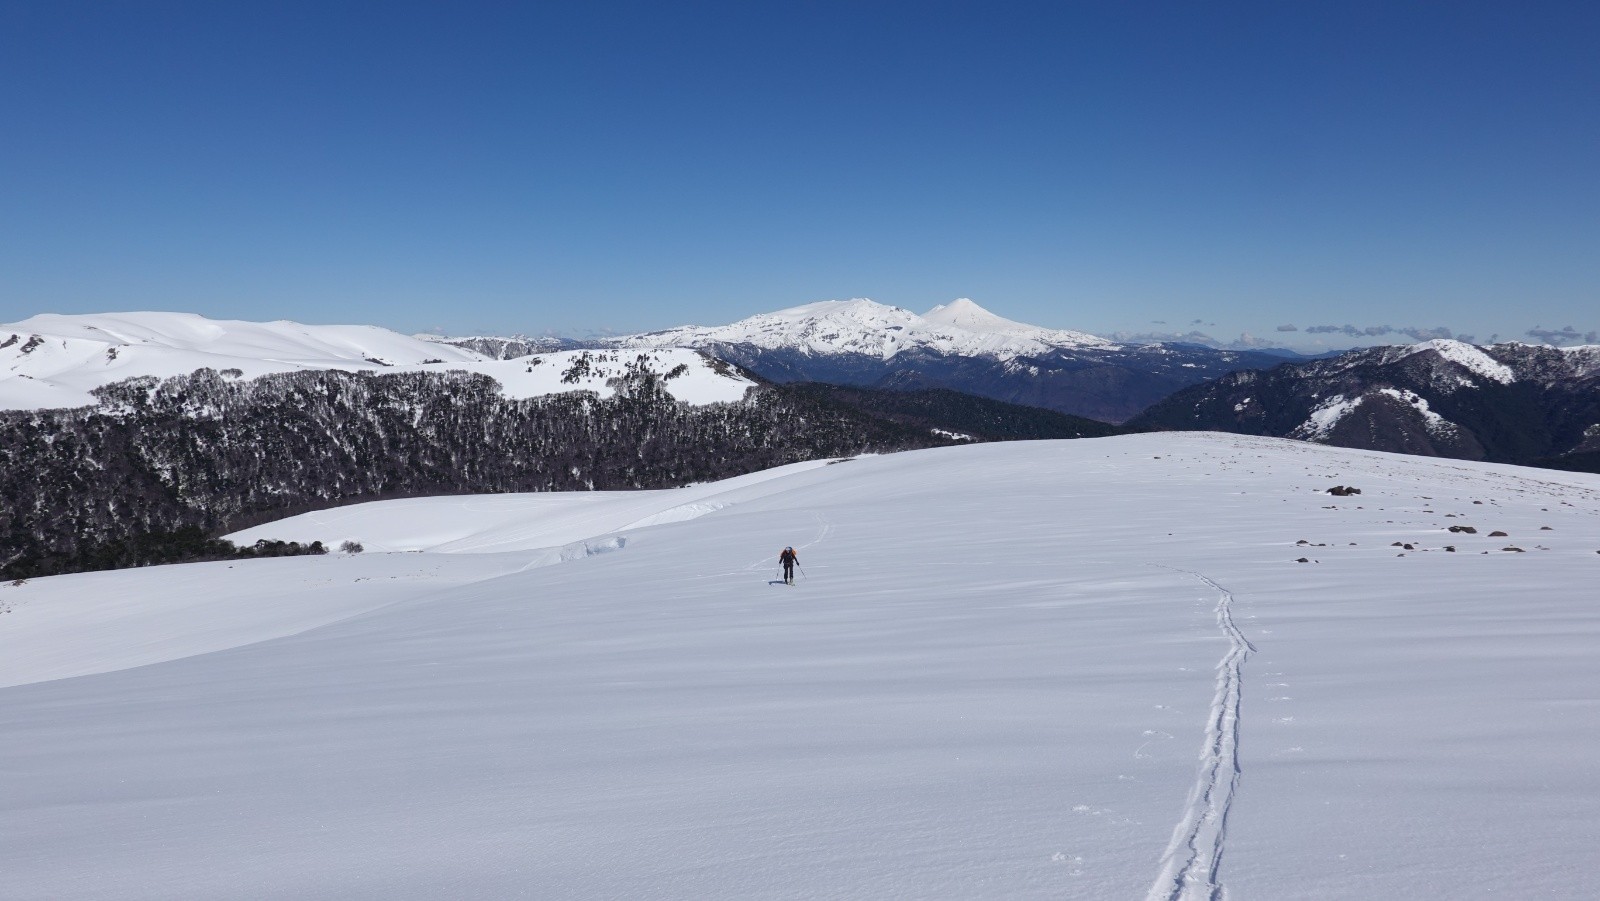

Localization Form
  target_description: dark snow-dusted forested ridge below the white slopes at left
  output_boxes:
[0,366,1100,578]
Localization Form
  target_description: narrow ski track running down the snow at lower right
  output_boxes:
[1146,567,1256,901]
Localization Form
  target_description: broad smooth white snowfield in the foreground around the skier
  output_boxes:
[0,432,1600,901]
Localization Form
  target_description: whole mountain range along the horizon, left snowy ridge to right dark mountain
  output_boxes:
[0,307,1600,489]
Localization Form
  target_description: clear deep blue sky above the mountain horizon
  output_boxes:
[0,0,1600,346]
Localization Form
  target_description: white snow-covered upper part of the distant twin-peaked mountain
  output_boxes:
[618,299,1112,360]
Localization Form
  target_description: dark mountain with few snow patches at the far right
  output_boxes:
[1136,341,1600,471]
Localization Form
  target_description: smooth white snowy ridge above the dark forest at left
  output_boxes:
[0,312,752,410]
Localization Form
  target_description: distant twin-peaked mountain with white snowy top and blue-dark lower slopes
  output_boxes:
[610,299,1283,422]
